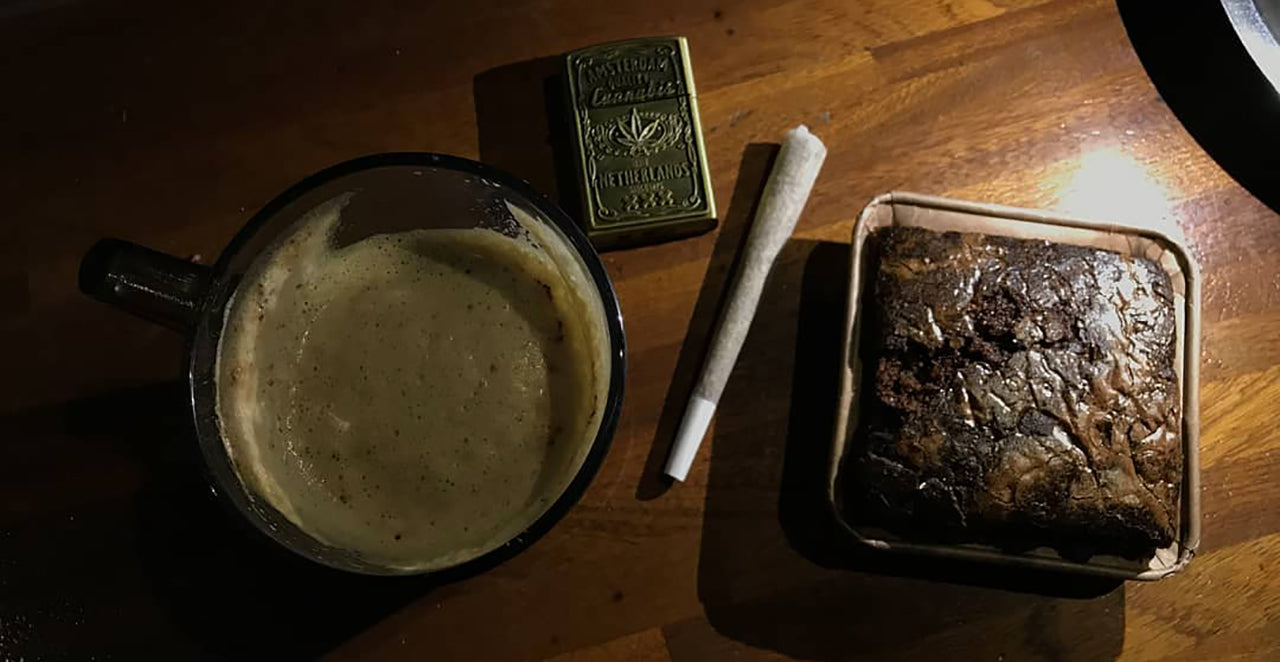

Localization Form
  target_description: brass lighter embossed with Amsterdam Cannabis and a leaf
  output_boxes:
[566,37,716,248]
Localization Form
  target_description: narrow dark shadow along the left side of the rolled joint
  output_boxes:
[636,142,778,501]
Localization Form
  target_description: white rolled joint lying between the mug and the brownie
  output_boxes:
[666,124,827,481]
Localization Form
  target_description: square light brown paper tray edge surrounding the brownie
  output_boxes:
[827,192,1201,581]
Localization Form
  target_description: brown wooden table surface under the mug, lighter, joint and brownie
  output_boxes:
[0,0,1280,661]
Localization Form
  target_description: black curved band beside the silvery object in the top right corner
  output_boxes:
[1116,0,1280,213]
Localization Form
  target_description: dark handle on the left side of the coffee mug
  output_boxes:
[79,239,212,330]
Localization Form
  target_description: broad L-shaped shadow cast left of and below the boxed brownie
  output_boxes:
[696,239,1124,661]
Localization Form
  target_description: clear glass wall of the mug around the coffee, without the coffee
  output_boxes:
[189,154,625,575]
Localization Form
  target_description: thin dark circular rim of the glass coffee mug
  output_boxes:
[186,152,626,579]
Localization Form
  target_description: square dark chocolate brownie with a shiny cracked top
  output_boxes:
[841,228,1183,557]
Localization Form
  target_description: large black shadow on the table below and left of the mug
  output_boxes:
[0,382,430,659]
